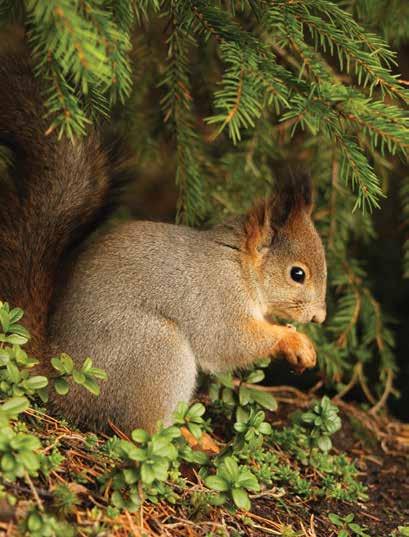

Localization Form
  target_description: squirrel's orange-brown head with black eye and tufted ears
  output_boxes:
[244,175,327,323]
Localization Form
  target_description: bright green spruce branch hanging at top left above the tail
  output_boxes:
[25,0,132,138]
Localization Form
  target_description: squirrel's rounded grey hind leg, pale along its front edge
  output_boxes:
[48,311,197,434]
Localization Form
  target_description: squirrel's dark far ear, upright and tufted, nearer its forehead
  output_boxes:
[271,173,312,227]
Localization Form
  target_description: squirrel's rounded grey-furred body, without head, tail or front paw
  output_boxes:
[51,217,325,431]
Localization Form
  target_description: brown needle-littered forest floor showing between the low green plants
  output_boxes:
[0,387,409,537]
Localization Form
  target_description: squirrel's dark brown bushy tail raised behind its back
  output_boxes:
[0,30,124,355]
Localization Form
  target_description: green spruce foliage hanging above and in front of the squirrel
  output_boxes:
[0,0,409,404]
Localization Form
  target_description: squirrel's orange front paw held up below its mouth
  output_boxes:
[277,330,317,373]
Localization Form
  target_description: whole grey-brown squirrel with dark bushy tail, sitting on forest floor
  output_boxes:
[0,32,327,431]
